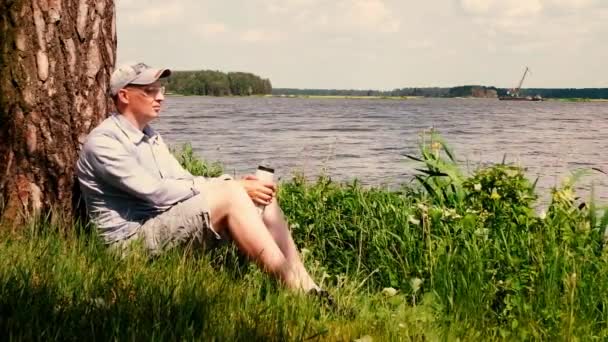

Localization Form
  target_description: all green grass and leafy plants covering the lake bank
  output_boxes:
[0,135,608,341]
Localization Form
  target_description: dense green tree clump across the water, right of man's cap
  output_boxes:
[164,70,272,96]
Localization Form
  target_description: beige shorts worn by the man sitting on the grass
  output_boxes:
[119,194,222,255]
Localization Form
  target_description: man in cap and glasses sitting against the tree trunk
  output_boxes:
[77,63,327,296]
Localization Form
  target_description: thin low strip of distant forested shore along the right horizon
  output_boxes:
[272,86,608,99]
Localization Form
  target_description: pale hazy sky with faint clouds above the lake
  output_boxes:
[115,0,608,90]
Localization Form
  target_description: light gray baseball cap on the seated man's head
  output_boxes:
[110,63,171,96]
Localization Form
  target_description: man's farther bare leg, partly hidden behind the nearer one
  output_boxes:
[263,198,319,291]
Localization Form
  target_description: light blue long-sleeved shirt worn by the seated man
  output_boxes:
[76,114,206,243]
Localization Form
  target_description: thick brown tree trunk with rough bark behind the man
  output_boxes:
[0,0,116,227]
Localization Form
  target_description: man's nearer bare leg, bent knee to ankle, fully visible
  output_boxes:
[201,181,308,290]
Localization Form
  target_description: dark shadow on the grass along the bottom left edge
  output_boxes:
[0,272,322,341]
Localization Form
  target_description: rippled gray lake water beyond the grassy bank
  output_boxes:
[153,96,608,202]
